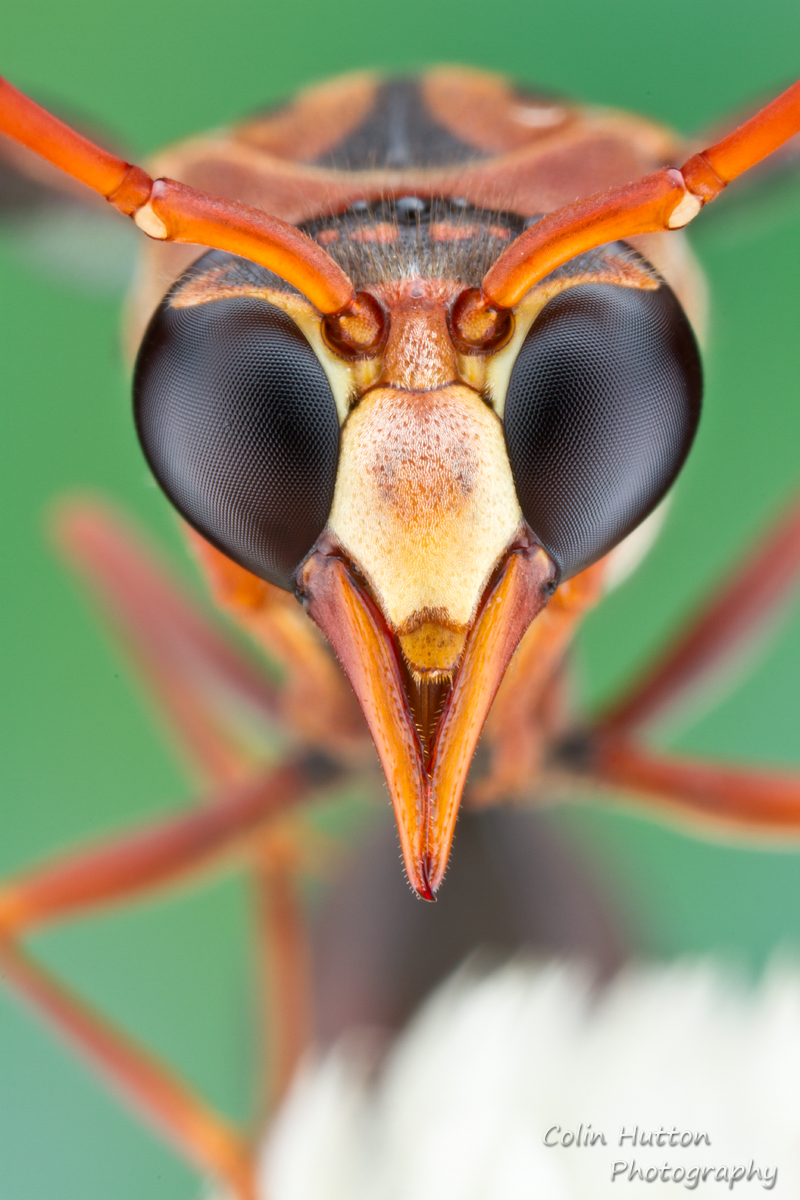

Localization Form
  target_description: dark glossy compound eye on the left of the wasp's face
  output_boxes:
[133,296,339,590]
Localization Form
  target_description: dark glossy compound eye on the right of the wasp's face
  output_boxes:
[504,283,702,578]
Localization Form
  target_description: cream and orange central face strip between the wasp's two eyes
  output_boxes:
[329,278,522,696]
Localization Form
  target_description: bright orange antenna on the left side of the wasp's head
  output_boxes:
[0,78,362,316]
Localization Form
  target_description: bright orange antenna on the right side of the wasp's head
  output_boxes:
[464,82,800,316]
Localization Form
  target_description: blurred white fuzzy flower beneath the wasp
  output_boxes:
[261,964,800,1200]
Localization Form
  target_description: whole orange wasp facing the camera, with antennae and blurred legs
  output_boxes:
[0,68,800,1200]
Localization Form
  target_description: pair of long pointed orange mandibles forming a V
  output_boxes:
[300,530,555,900]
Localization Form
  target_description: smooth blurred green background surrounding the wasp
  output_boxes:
[0,0,800,1200]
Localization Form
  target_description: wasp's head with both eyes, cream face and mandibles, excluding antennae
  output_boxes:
[136,204,700,899]
